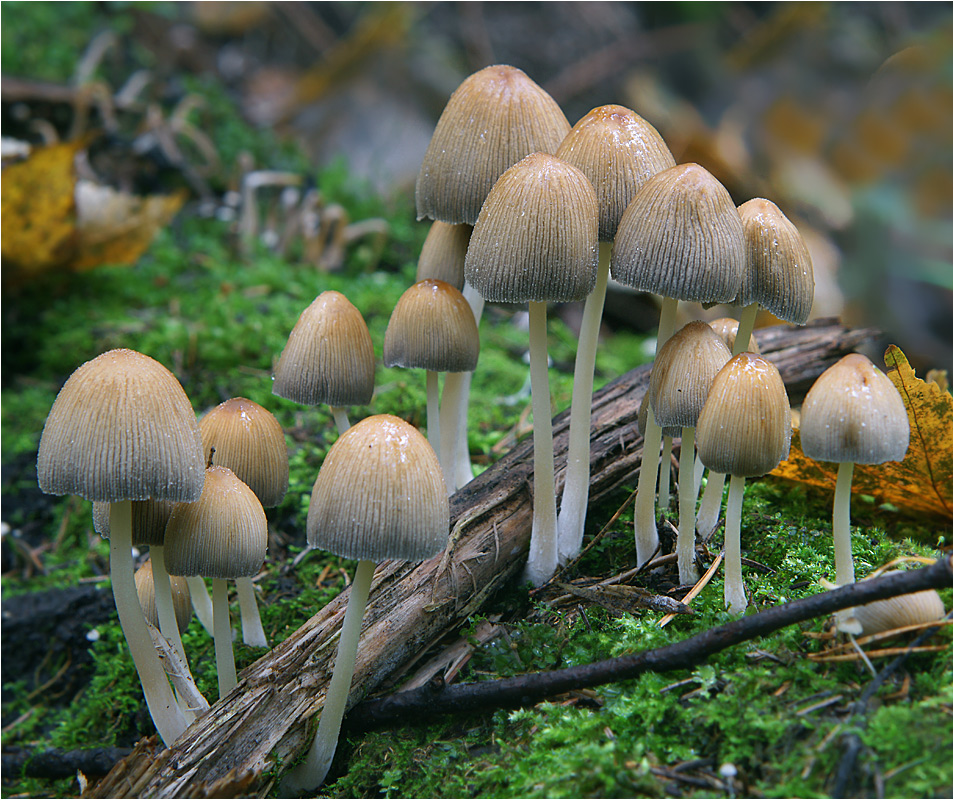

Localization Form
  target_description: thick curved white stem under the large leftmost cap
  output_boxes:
[109,500,186,747]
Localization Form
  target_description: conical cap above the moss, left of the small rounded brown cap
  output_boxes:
[272,291,374,406]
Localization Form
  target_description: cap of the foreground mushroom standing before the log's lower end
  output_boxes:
[307,414,450,561]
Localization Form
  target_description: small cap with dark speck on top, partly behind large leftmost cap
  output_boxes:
[165,467,268,578]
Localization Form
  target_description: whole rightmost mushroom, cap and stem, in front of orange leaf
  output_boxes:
[799,353,910,633]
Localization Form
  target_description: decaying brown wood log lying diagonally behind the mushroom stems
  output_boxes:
[87,320,876,797]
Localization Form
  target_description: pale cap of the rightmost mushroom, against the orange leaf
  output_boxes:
[799,353,910,464]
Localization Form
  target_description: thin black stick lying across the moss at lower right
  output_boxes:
[343,556,952,733]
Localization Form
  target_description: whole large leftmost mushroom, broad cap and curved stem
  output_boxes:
[37,349,205,746]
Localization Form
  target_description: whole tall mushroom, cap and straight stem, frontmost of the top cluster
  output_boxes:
[464,153,599,586]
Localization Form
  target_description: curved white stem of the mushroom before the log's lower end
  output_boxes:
[281,561,375,797]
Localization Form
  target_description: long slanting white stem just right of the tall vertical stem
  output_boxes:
[557,242,613,562]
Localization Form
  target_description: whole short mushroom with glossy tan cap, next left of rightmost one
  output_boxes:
[696,353,792,614]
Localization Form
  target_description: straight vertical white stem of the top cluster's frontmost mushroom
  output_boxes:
[527,300,557,586]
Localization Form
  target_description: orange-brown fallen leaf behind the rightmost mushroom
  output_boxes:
[770,345,954,520]
